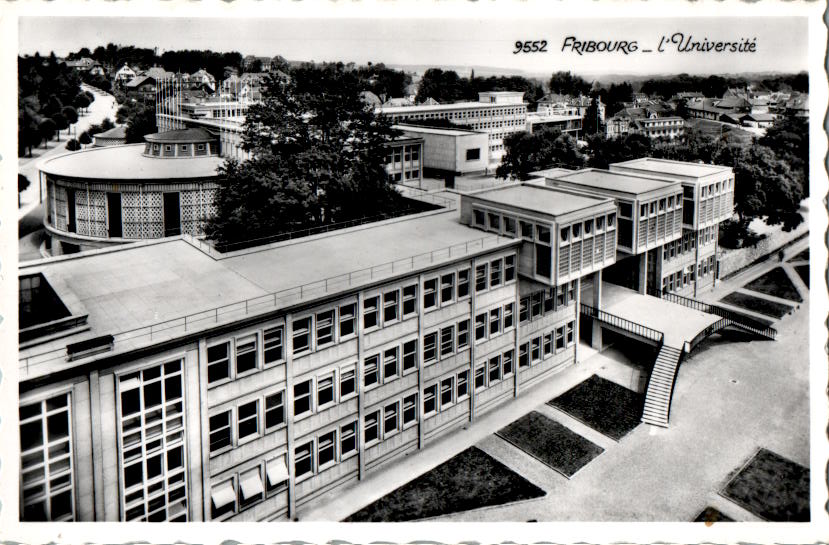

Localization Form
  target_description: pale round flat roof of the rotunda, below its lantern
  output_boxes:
[38,144,224,181]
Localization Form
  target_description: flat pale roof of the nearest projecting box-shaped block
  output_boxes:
[470,184,610,216]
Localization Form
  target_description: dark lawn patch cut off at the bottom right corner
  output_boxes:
[720,449,809,522]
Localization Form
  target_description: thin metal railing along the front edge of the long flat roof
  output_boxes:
[20,235,514,378]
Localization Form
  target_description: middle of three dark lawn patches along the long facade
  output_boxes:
[497,411,604,479]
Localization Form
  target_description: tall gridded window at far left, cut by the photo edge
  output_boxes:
[20,394,74,522]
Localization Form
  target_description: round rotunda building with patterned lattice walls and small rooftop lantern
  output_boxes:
[39,128,223,255]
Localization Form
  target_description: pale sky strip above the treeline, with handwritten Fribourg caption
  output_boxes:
[19,17,808,75]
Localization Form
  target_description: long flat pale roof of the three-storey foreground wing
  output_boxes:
[19,211,518,378]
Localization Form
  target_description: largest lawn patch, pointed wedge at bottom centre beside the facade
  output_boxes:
[344,447,545,522]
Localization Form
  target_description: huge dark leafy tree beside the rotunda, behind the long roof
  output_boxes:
[206,63,401,245]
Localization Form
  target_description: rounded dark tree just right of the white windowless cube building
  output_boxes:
[495,128,584,180]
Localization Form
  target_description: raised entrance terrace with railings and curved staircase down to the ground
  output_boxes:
[581,282,777,428]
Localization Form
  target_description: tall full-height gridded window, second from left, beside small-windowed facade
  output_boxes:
[118,360,187,522]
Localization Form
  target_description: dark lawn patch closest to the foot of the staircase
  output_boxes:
[547,375,645,441]
